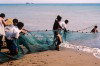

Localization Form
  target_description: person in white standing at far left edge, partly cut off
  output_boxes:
[0,13,5,51]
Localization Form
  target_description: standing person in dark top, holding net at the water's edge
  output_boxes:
[53,15,62,51]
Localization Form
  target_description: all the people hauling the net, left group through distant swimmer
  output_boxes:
[0,13,98,55]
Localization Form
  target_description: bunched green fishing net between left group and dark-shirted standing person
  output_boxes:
[0,31,55,62]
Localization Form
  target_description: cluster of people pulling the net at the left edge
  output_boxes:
[0,13,25,55]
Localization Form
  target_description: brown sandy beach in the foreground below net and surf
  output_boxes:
[0,48,100,66]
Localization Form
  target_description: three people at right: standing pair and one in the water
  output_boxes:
[53,15,98,51]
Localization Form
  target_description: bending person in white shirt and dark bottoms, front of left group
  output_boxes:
[5,22,24,55]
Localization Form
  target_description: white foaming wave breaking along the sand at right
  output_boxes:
[60,42,100,59]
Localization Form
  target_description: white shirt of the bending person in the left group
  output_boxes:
[5,25,21,40]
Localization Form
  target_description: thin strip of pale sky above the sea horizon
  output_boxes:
[0,0,100,4]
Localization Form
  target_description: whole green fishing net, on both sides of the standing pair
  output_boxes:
[0,30,100,63]
